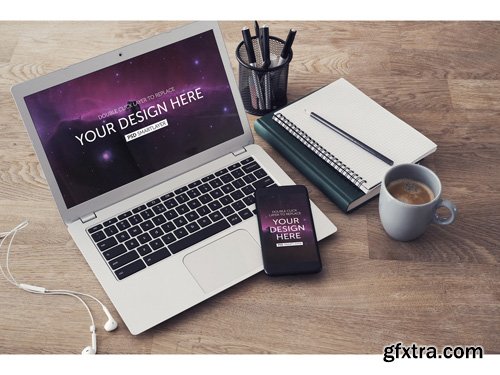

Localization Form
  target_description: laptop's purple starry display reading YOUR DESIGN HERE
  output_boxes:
[25,31,243,208]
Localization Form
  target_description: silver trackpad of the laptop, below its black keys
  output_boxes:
[183,229,262,293]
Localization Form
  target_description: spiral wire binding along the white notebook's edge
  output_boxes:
[273,113,366,187]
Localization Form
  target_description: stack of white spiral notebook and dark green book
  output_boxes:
[255,79,437,212]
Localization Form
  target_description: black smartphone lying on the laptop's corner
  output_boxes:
[255,185,321,276]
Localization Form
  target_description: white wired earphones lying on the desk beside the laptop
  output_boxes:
[0,221,118,354]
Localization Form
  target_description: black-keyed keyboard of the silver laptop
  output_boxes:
[87,157,275,280]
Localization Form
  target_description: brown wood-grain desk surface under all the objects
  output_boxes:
[0,21,500,353]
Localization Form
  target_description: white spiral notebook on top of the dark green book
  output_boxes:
[273,78,437,194]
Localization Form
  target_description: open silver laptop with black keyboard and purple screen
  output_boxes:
[12,22,336,335]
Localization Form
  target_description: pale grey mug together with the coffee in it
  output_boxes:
[379,164,457,241]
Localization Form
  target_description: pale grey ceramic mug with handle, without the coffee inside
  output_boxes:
[379,164,457,241]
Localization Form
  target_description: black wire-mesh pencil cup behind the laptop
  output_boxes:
[236,36,293,116]
